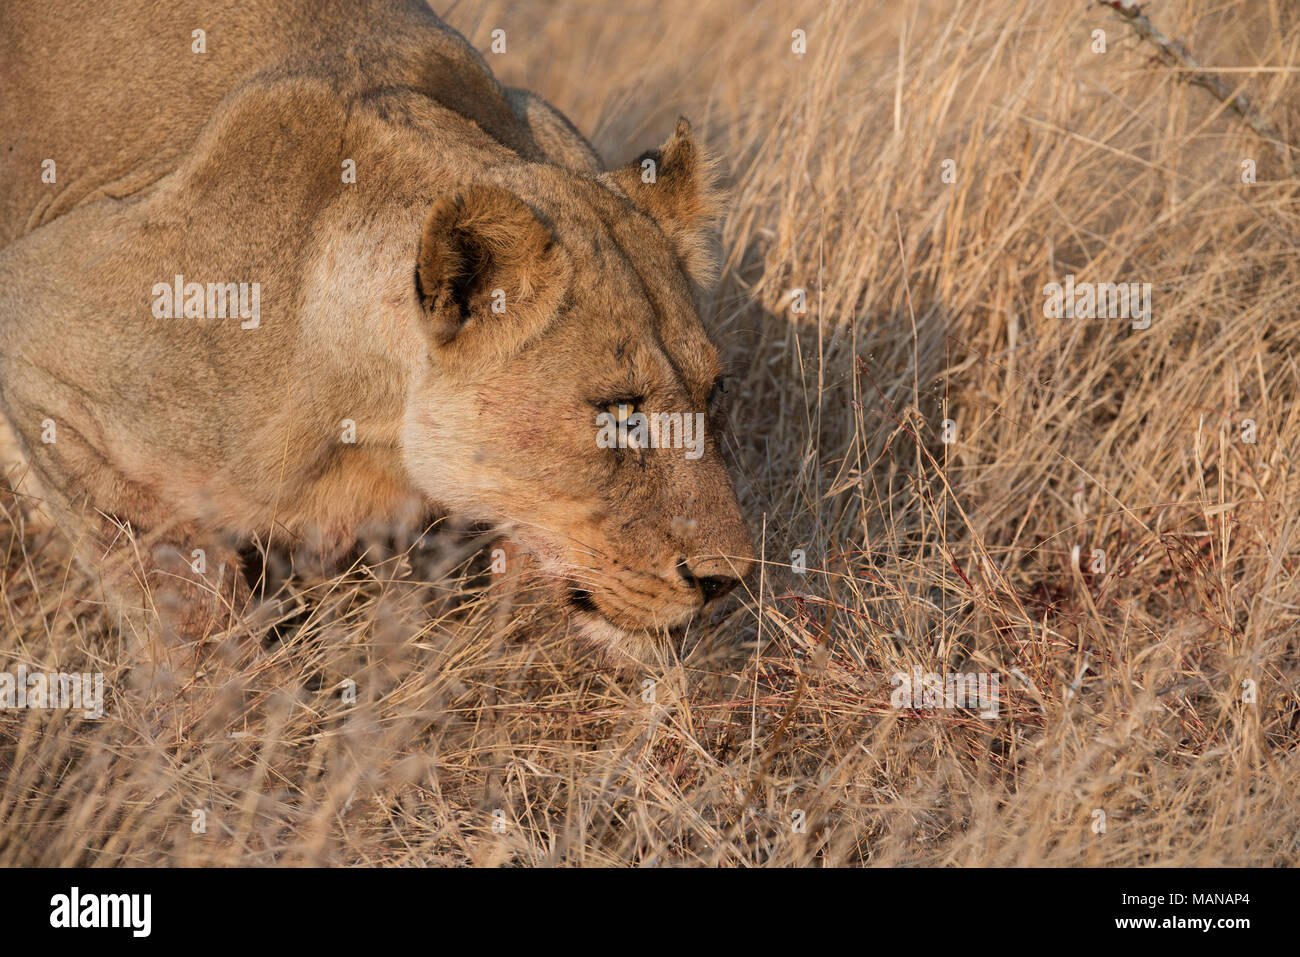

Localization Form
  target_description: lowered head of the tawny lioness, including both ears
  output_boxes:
[402,121,754,653]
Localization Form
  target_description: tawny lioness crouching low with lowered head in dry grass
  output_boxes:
[0,0,753,649]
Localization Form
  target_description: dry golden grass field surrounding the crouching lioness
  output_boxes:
[0,0,1300,866]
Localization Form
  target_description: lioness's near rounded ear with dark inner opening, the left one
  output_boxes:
[416,185,556,345]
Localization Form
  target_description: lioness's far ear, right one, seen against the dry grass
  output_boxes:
[601,117,722,286]
